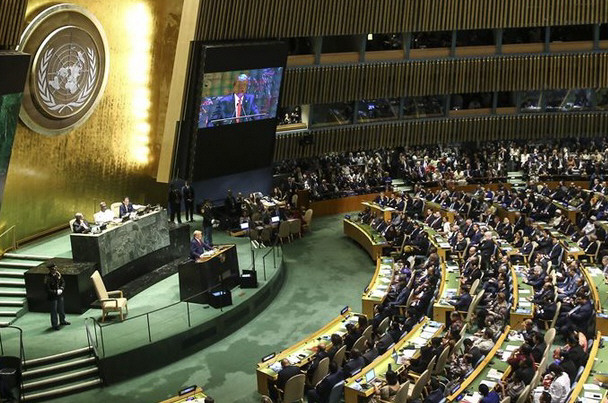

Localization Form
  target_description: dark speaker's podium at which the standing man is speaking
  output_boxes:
[178,245,240,304]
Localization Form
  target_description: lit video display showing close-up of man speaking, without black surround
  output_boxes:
[198,67,283,128]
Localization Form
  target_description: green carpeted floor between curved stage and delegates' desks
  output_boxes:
[40,215,375,403]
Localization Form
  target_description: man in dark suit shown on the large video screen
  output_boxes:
[209,74,261,126]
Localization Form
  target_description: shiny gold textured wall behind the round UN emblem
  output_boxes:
[0,0,183,239]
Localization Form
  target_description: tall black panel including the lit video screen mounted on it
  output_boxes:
[175,41,287,181]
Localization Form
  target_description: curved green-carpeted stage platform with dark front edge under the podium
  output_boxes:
[3,222,284,383]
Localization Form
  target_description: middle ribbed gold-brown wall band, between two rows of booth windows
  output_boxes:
[281,52,608,106]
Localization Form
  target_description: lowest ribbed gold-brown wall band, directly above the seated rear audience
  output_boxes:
[274,112,608,161]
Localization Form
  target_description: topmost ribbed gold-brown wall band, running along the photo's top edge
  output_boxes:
[197,0,608,40]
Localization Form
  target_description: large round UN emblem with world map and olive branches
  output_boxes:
[19,4,108,134]
